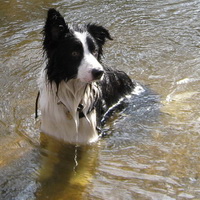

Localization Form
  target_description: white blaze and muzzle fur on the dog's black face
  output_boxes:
[74,32,103,83]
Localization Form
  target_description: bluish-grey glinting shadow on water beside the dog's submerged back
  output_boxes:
[101,83,162,145]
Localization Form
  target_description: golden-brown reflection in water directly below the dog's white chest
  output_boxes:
[36,134,98,200]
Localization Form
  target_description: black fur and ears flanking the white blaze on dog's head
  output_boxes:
[43,8,112,85]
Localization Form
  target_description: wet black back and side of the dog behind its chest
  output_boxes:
[96,68,136,126]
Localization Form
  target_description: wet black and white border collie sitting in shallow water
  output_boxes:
[38,9,138,144]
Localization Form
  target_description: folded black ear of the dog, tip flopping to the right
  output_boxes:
[87,24,112,47]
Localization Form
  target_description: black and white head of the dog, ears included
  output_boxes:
[43,9,112,84]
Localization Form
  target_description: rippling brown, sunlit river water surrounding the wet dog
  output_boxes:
[0,0,200,200]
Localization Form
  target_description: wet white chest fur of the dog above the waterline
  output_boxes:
[39,70,99,143]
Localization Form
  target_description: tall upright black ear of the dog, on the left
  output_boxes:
[43,8,69,49]
